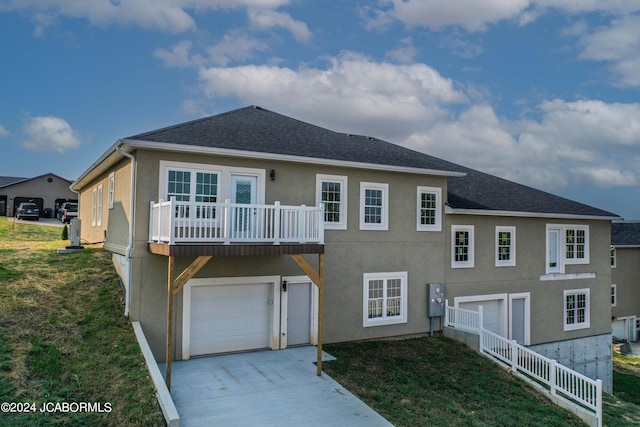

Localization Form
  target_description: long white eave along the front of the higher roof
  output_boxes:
[121,139,466,177]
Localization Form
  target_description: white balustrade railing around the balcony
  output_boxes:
[149,198,324,245]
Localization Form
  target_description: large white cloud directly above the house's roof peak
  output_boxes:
[200,52,467,138]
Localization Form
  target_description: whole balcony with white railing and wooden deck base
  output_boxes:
[149,198,324,256]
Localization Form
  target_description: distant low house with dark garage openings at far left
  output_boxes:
[0,173,78,217]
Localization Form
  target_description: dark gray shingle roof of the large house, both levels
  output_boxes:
[126,107,617,217]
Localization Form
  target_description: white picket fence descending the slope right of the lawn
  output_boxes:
[445,301,602,427]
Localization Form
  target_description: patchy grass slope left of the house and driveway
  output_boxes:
[0,221,164,426]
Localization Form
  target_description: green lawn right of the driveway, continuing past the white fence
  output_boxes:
[323,336,640,427]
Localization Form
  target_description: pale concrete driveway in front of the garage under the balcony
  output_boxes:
[160,347,391,427]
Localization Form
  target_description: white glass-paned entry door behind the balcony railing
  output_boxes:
[231,175,258,239]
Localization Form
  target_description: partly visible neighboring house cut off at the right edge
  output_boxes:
[611,221,640,341]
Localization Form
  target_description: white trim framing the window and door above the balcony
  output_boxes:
[158,160,266,205]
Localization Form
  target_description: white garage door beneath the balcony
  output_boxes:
[190,283,273,356]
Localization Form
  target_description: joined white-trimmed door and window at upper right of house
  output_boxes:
[546,224,589,274]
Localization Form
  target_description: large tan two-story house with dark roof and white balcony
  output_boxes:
[72,107,618,389]
